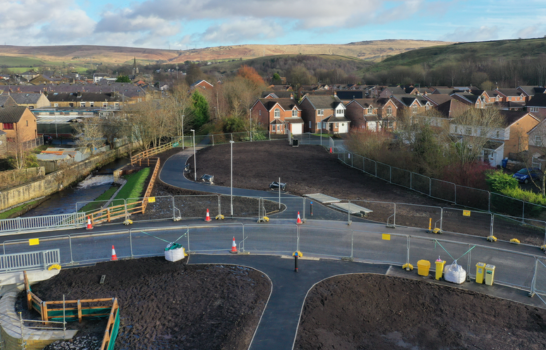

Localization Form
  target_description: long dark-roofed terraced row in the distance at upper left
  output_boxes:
[48,92,125,109]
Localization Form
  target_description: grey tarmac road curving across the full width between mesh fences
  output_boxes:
[3,224,546,306]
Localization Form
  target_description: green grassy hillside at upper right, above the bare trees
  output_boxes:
[370,38,546,72]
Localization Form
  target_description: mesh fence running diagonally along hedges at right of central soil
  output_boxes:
[338,152,546,220]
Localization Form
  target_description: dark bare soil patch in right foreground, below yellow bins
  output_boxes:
[295,275,546,350]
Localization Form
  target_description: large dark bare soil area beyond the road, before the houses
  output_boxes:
[189,141,544,245]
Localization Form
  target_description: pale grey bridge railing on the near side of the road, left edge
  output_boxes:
[0,249,61,273]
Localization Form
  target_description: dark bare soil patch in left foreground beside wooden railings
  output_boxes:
[21,258,271,350]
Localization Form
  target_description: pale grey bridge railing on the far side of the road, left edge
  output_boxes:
[0,213,85,233]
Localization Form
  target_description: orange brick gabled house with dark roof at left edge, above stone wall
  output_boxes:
[0,107,38,143]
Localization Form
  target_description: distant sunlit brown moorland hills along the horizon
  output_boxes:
[0,40,446,67]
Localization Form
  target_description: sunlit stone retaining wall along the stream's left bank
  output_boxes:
[0,145,133,210]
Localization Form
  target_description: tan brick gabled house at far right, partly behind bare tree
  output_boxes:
[450,111,540,166]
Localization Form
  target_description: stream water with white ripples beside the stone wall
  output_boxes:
[22,158,129,217]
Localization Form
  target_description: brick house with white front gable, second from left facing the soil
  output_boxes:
[299,95,351,134]
